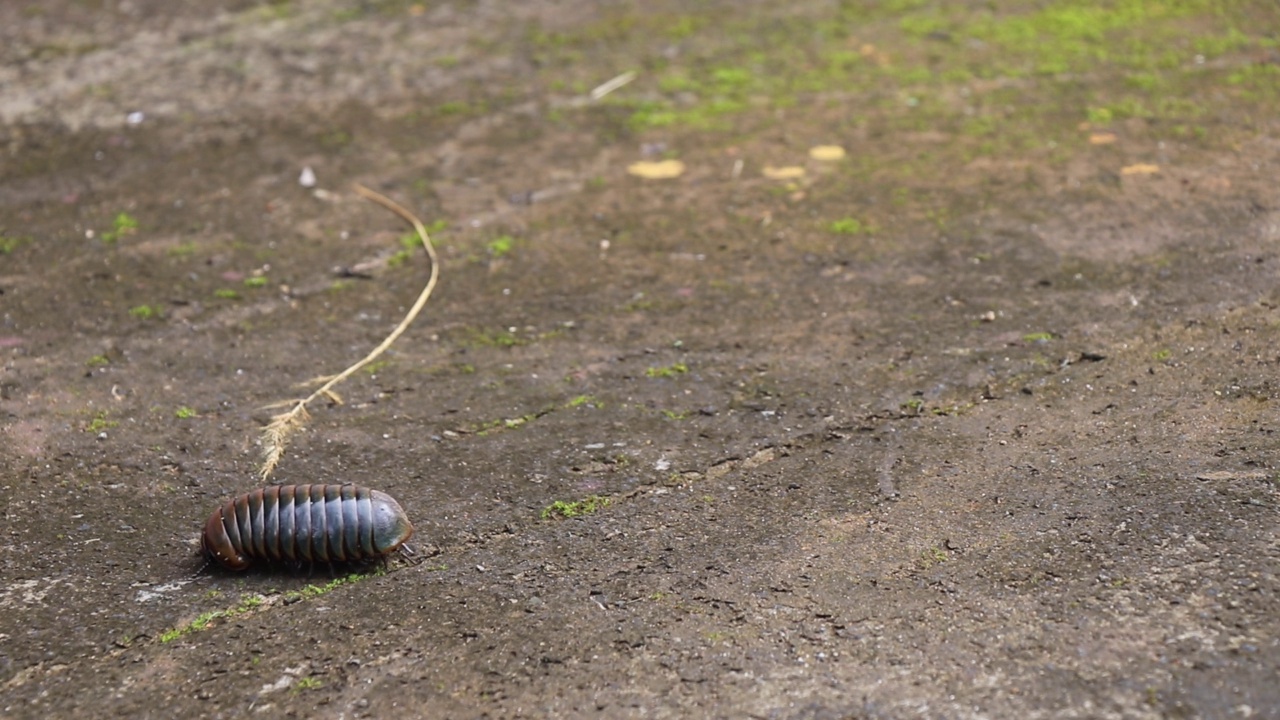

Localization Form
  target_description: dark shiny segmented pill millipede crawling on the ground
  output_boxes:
[201,484,413,570]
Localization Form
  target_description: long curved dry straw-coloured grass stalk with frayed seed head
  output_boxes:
[259,183,440,482]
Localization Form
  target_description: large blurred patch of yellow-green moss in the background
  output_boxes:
[542,0,1280,169]
